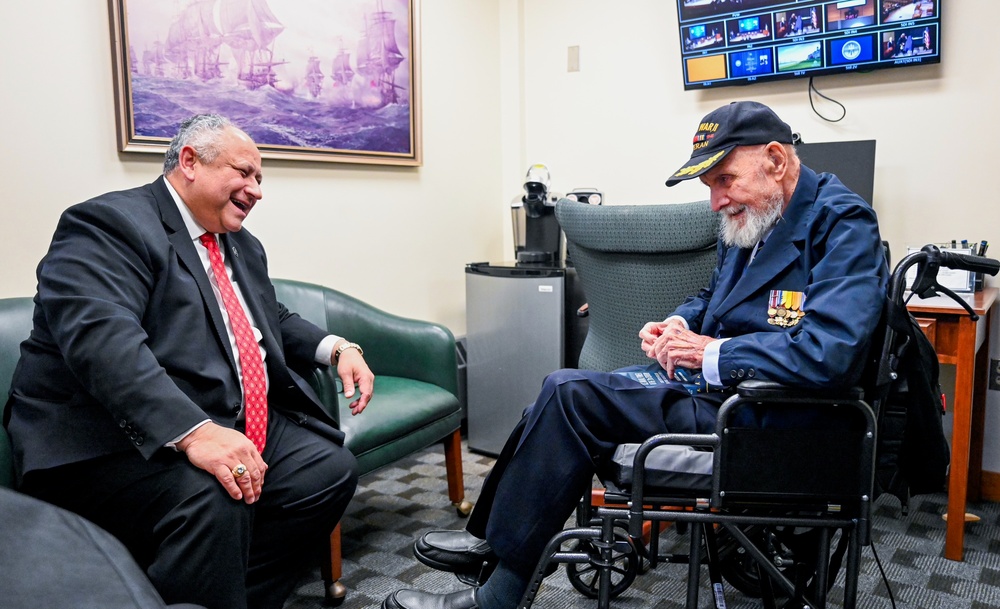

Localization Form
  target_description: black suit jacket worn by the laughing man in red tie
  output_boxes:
[6,177,343,477]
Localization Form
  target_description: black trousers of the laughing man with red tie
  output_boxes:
[23,409,358,609]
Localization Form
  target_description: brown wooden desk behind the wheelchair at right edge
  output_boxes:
[907,288,998,560]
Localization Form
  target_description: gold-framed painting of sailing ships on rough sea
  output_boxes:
[109,0,421,165]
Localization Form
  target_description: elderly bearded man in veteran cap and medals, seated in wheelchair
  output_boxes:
[383,102,888,609]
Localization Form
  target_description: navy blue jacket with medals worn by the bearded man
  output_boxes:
[674,166,888,387]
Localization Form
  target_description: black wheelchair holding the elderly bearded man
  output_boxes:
[519,245,1000,609]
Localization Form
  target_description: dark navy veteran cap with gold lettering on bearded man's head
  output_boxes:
[667,101,792,186]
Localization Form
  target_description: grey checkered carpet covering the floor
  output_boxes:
[285,446,1000,609]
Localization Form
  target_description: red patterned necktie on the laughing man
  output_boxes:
[201,233,267,453]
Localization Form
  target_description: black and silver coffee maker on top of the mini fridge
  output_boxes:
[510,164,563,266]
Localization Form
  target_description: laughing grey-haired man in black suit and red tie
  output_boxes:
[5,115,374,609]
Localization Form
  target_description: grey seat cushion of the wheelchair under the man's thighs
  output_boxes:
[602,444,713,494]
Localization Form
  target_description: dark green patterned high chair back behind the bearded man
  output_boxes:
[556,199,719,371]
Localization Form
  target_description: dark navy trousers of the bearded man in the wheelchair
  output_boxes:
[467,370,728,575]
